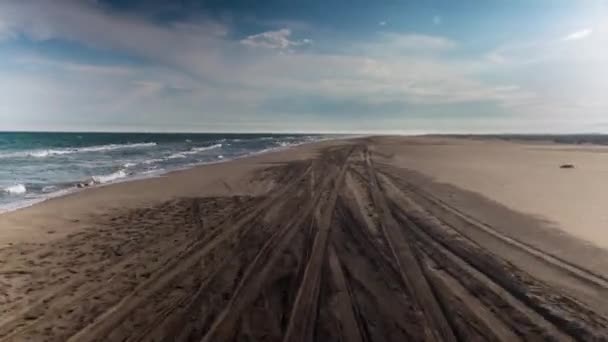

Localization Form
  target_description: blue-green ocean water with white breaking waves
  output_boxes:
[0,132,329,212]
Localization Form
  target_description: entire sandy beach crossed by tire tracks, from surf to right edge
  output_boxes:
[0,137,608,341]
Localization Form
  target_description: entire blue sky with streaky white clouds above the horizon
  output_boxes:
[0,0,608,134]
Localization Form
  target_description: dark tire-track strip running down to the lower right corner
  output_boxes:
[384,178,608,340]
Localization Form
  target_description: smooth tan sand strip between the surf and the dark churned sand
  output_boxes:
[0,137,349,248]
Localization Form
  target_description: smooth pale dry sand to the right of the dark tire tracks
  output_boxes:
[376,138,608,248]
